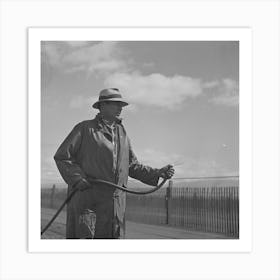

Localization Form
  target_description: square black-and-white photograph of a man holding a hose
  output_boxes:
[41,41,239,242]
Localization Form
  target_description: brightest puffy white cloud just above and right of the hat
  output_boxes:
[105,72,202,109]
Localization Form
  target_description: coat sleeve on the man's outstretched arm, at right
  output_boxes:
[128,141,159,186]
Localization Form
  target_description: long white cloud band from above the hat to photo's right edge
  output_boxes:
[104,71,239,109]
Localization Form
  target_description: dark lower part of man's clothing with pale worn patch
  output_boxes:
[66,186,125,239]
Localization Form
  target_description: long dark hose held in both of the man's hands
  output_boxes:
[41,179,167,235]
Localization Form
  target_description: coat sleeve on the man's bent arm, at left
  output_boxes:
[54,123,86,187]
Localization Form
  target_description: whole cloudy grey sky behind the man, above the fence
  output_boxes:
[41,41,239,183]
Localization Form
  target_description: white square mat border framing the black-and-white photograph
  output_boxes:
[28,27,252,253]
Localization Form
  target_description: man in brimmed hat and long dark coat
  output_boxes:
[54,88,174,239]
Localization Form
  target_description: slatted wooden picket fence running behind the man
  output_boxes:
[41,181,239,238]
